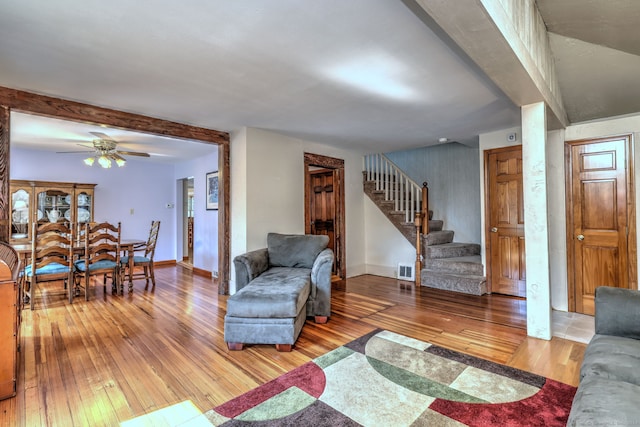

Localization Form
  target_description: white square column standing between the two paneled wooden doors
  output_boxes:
[522,102,552,340]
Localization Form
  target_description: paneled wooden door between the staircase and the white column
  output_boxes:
[485,146,526,297]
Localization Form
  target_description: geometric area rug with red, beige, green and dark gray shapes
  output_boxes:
[204,329,576,427]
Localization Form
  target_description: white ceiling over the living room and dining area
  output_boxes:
[0,0,640,160]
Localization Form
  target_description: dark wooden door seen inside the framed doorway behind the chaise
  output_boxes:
[309,169,337,273]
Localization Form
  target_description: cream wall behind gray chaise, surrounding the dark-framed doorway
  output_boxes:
[230,128,365,293]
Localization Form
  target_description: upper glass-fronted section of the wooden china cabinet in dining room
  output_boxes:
[9,180,96,243]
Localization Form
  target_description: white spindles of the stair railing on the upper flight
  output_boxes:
[363,154,422,223]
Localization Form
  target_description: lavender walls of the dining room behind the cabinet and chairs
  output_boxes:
[10,148,217,271]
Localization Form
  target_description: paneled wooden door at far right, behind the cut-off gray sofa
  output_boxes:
[566,135,637,314]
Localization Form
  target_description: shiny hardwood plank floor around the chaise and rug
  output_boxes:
[0,267,585,426]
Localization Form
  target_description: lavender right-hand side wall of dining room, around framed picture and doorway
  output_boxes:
[172,150,219,272]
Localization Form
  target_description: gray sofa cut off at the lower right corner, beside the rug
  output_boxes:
[567,286,640,426]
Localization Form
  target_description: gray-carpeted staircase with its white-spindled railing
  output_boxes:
[363,154,487,295]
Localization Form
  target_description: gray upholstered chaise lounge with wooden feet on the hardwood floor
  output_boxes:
[224,233,333,351]
